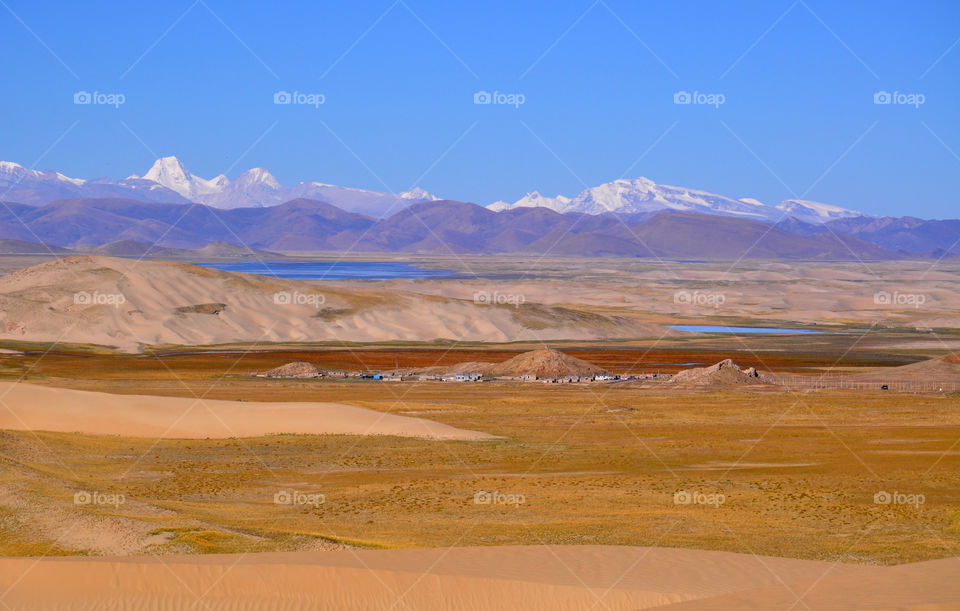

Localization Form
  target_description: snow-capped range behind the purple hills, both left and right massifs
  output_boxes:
[0,157,864,224]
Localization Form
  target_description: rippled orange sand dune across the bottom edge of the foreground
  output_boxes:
[0,546,960,611]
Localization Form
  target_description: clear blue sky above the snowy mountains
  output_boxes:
[0,0,960,218]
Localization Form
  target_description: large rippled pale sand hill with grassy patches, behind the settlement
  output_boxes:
[0,256,663,350]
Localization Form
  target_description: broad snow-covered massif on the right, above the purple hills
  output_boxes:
[489,178,863,223]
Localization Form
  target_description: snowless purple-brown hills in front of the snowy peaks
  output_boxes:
[0,199,896,260]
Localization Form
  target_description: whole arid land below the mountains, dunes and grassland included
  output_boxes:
[0,257,960,609]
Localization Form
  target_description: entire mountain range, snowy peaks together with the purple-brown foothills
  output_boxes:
[0,157,960,259]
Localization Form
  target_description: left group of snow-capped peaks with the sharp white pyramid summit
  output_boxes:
[0,157,437,217]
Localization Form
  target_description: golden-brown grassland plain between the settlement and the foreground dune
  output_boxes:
[0,372,960,563]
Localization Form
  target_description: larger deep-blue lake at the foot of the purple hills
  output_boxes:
[201,261,460,280]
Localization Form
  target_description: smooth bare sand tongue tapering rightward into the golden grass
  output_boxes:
[0,382,490,439]
